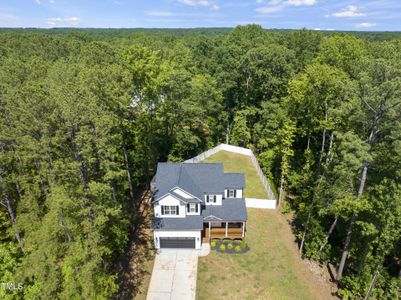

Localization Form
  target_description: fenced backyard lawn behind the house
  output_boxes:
[202,151,267,199]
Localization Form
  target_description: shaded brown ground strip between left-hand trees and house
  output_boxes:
[115,189,155,299]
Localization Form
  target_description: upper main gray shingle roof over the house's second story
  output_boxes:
[153,163,245,201]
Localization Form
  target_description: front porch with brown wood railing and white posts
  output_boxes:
[202,221,246,243]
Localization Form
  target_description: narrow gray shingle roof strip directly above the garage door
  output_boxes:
[152,216,203,230]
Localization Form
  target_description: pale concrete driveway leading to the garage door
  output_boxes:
[147,249,200,300]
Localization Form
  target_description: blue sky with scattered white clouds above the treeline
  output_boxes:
[0,0,401,31]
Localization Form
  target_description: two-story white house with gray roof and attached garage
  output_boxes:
[152,163,247,249]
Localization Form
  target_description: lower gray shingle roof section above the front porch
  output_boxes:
[202,199,247,222]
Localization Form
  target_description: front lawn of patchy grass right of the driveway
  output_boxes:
[196,209,337,300]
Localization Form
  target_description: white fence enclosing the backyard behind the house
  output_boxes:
[185,144,276,209]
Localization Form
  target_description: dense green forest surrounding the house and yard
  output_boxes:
[0,25,401,299]
